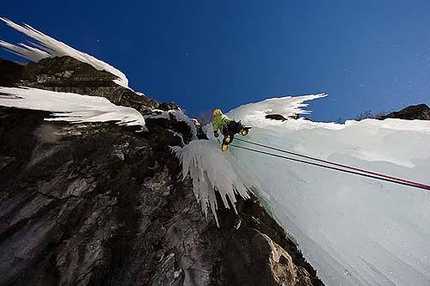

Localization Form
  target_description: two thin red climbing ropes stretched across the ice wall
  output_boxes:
[230,138,430,190]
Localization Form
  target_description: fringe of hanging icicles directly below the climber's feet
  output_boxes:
[172,140,259,226]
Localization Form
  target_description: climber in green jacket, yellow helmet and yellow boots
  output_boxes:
[212,109,251,152]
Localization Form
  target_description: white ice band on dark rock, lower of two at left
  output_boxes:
[0,87,145,128]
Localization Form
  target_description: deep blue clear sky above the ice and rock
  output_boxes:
[0,0,430,121]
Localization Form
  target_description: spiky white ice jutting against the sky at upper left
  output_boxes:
[0,17,128,88]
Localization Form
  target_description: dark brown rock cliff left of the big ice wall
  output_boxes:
[0,57,322,285]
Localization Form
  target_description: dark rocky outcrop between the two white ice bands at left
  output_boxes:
[0,56,158,114]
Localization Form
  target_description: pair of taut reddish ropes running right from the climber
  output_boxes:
[235,138,430,190]
